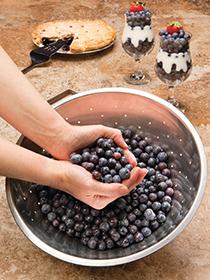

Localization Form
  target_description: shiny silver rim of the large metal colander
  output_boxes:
[6,87,207,267]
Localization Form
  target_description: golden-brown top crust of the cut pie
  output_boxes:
[32,20,116,53]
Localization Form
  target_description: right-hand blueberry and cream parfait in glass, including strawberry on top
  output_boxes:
[155,21,192,108]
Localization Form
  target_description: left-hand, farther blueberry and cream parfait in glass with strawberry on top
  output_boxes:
[122,2,154,85]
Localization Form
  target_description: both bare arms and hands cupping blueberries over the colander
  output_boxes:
[0,47,147,209]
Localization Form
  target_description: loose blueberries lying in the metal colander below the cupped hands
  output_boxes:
[38,128,174,250]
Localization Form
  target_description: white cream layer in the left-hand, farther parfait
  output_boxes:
[122,22,154,48]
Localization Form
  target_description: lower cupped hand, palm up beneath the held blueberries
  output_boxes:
[54,160,147,209]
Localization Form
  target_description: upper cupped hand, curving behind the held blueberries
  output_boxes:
[47,123,137,167]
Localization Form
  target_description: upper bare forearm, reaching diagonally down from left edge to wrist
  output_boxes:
[0,47,70,152]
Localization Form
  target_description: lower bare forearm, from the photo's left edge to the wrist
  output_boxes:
[0,138,57,186]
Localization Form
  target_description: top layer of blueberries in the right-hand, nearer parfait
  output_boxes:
[159,29,191,53]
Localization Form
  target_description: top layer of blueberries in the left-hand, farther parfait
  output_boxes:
[126,9,152,28]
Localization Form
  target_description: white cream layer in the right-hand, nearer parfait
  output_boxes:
[157,49,191,74]
